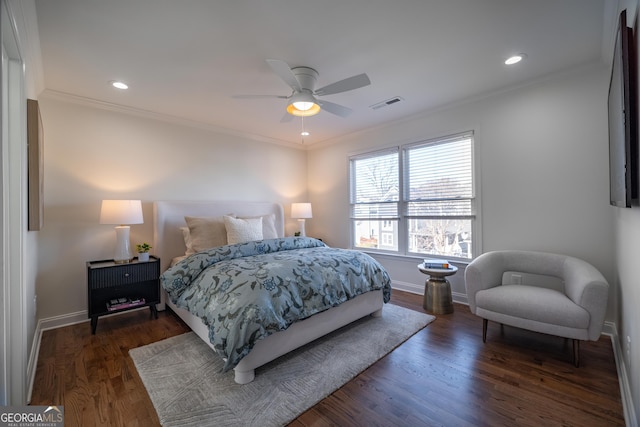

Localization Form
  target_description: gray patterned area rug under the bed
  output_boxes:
[129,304,435,427]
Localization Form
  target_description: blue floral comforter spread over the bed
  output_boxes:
[161,237,391,371]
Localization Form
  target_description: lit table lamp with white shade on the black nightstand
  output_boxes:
[100,200,144,264]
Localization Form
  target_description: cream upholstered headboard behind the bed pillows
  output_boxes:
[153,201,284,271]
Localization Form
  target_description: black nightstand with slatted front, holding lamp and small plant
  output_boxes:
[87,256,160,334]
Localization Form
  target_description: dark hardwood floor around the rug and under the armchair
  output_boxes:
[31,291,624,427]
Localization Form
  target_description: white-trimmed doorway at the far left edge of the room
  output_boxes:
[0,0,28,406]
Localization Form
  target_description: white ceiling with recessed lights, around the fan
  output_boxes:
[36,0,606,145]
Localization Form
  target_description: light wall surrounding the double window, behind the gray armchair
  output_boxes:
[308,64,616,312]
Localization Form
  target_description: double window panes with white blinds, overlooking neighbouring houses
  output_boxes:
[349,133,477,259]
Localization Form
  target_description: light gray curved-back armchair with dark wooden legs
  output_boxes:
[465,251,609,366]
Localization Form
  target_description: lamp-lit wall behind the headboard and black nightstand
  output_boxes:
[36,93,306,320]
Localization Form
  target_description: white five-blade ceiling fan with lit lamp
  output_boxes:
[234,59,371,122]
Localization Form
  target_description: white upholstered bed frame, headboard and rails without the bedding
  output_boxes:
[153,201,383,384]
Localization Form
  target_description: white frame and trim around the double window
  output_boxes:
[349,131,482,263]
